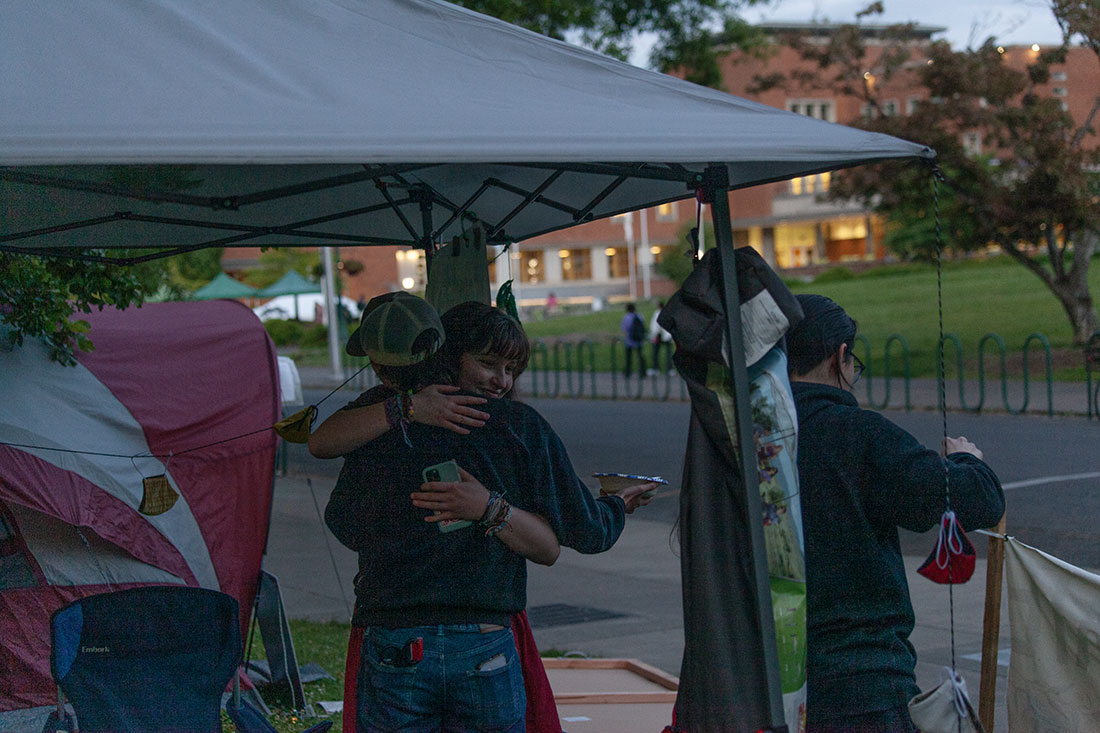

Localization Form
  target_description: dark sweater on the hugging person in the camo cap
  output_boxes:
[325,387,626,628]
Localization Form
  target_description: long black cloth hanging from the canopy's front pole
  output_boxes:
[660,248,804,733]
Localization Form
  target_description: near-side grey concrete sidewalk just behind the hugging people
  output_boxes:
[264,475,1009,731]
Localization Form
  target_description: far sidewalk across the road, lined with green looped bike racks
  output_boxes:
[298,367,1096,415]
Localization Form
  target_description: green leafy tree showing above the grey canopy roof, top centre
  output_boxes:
[457,0,767,87]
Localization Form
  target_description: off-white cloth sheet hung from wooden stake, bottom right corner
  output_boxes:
[1004,537,1100,733]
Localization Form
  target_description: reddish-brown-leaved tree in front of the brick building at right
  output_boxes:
[772,0,1100,344]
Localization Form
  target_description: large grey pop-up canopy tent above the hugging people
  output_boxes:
[0,0,935,731]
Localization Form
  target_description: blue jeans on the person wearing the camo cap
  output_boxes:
[356,624,527,733]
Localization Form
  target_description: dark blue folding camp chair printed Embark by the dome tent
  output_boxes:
[51,586,241,733]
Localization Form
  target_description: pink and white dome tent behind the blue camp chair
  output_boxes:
[0,300,279,727]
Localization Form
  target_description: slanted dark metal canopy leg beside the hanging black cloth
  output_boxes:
[703,163,788,731]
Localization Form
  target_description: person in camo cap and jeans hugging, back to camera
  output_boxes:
[310,293,652,731]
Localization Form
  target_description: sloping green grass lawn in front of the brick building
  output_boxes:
[281,256,1100,384]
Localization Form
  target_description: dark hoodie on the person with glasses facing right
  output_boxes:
[791,382,1004,722]
